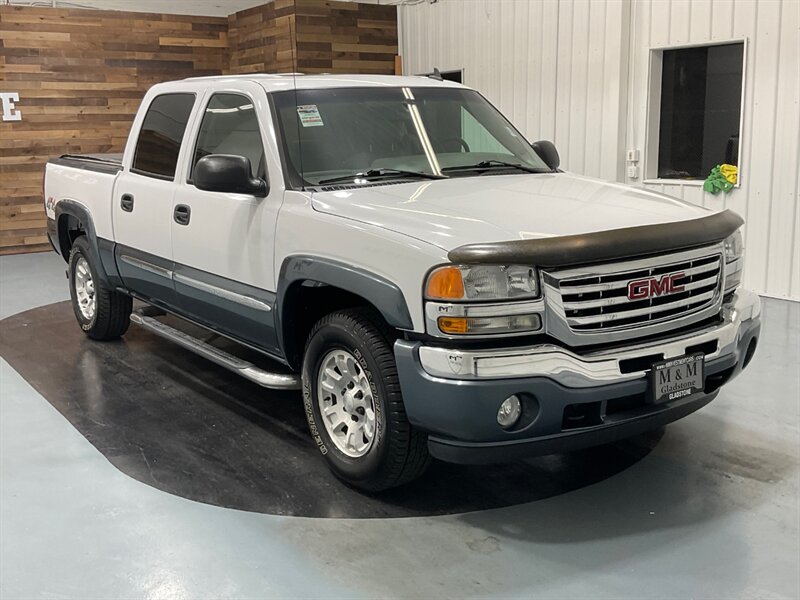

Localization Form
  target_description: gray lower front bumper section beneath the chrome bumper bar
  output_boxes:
[394,318,761,463]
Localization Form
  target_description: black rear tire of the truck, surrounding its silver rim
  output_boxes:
[69,236,133,340]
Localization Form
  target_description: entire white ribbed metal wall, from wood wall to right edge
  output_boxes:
[398,0,800,300]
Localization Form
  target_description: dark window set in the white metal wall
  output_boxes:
[658,42,744,179]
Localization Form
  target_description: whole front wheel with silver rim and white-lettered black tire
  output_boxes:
[303,308,430,491]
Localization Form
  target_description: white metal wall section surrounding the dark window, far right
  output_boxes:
[627,0,800,299]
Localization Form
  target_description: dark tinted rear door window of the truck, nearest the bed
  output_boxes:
[131,94,195,179]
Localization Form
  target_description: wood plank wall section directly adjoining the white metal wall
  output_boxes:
[296,0,397,75]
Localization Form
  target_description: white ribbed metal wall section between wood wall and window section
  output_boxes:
[399,0,628,180]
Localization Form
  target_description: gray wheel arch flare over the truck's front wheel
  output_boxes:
[274,255,414,359]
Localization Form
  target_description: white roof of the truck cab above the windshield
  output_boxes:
[178,73,465,92]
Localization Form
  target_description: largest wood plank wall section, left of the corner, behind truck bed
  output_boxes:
[0,6,228,254]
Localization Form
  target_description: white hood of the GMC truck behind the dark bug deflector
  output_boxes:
[312,173,712,251]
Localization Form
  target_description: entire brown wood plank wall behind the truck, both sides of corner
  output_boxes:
[0,0,397,254]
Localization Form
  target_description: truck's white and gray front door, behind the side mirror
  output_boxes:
[172,81,283,352]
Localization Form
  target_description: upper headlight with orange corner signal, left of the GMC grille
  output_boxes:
[425,265,539,300]
